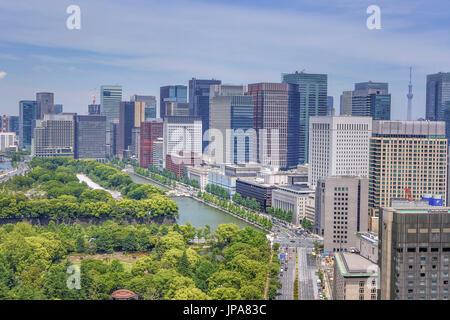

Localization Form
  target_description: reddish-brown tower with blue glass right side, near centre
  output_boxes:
[247,83,299,167]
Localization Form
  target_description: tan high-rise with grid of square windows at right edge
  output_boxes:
[369,121,447,230]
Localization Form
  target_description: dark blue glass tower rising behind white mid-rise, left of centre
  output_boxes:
[189,78,222,151]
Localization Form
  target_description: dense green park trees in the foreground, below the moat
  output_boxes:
[0,221,281,300]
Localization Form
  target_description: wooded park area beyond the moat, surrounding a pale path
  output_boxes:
[0,158,178,220]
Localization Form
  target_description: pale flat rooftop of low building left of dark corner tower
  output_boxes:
[335,252,377,277]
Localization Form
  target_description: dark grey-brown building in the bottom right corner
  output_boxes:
[378,206,450,300]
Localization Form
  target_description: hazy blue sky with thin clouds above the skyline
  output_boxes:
[0,0,450,119]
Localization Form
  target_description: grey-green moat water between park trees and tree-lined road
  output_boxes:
[130,173,251,231]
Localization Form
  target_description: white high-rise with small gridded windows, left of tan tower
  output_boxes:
[308,116,372,187]
